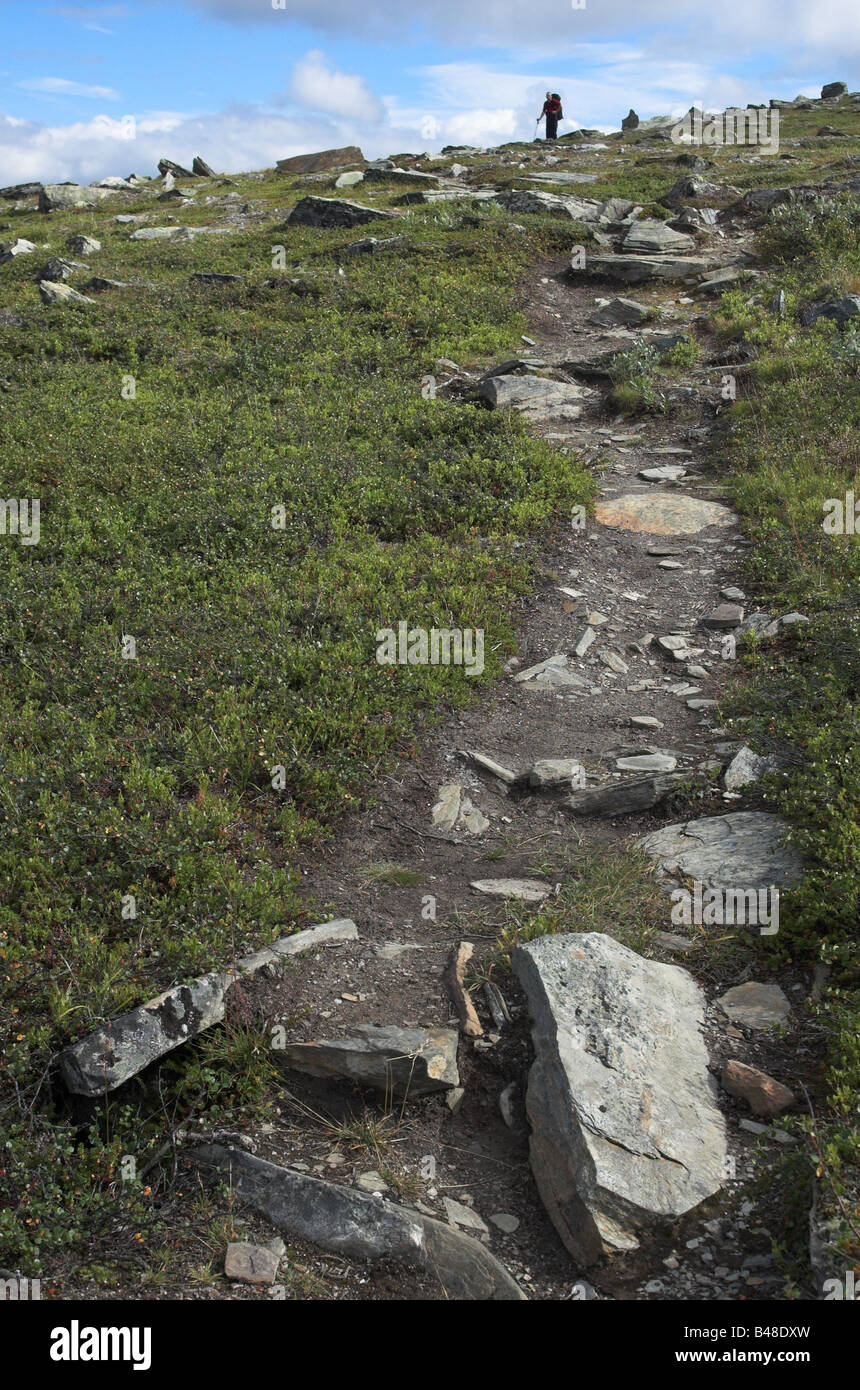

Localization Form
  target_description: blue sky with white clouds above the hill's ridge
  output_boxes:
[0,0,860,185]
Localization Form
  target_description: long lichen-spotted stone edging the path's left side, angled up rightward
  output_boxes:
[60,917,358,1095]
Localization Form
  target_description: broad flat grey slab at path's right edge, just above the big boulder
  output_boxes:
[636,810,803,890]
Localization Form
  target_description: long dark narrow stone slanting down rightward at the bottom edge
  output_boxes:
[193,1144,525,1301]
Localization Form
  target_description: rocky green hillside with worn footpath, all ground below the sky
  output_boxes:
[0,86,860,1301]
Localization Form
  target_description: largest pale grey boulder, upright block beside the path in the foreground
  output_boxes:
[511,933,727,1264]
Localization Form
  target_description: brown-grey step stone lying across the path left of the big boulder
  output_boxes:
[272,1023,460,1097]
